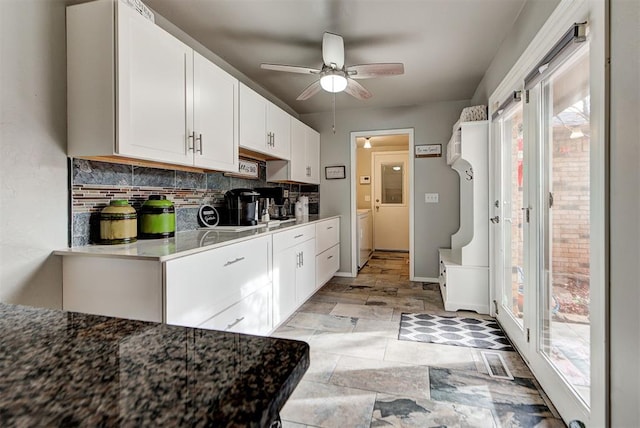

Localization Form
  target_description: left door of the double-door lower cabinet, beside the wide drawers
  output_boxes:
[273,247,299,326]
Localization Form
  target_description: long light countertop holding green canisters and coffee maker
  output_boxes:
[54,215,340,262]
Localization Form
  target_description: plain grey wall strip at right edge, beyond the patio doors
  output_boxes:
[609,0,640,427]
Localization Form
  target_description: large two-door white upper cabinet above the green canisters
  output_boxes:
[67,0,238,171]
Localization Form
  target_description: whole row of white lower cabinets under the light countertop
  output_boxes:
[58,218,340,335]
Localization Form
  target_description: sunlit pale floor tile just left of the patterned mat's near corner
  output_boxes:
[307,332,388,360]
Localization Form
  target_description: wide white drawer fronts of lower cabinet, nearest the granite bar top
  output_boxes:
[165,236,272,334]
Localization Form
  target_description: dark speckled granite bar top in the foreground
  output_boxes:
[0,303,309,427]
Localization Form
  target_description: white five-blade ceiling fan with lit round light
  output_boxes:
[260,32,404,101]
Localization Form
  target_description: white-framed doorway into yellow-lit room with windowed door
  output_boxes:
[351,129,414,280]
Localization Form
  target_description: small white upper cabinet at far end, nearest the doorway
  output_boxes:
[267,118,320,184]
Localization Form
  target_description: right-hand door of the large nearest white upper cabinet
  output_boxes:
[194,52,238,172]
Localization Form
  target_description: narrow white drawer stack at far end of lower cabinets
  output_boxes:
[316,218,340,289]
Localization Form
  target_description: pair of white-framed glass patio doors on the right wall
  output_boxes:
[491,27,592,424]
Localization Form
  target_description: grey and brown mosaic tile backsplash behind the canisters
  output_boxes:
[69,159,319,247]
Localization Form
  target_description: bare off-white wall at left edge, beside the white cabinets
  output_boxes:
[0,0,68,308]
